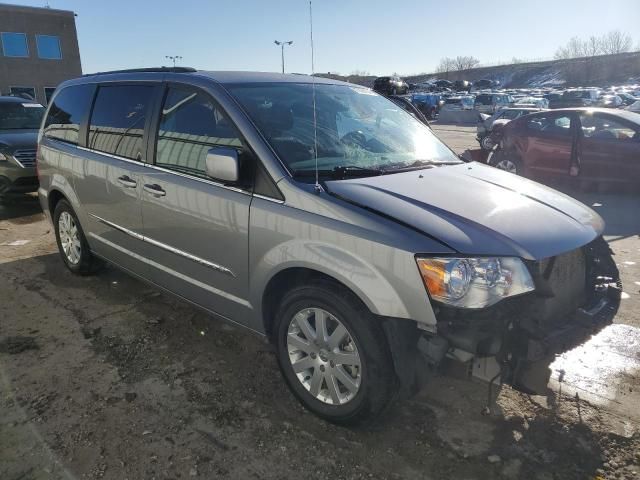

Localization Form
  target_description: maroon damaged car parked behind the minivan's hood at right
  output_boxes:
[487,108,640,188]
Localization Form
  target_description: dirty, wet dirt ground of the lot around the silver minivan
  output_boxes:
[0,131,640,480]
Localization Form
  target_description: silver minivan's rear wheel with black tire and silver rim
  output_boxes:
[53,200,102,275]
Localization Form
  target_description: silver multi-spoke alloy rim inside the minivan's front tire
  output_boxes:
[287,308,362,405]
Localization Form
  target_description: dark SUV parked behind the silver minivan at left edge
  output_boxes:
[0,97,44,196]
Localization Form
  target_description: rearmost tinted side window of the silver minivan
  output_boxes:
[44,85,93,145]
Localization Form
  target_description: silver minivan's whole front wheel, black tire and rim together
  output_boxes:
[275,281,398,425]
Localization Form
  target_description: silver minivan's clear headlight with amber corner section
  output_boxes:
[416,257,535,308]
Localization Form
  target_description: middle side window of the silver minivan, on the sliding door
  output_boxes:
[88,85,154,160]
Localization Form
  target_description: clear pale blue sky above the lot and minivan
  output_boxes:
[6,0,640,75]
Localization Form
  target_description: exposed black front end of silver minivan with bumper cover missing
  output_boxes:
[419,238,621,394]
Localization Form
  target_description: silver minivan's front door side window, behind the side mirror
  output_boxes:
[156,89,242,178]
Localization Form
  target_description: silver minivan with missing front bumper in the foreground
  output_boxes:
[38,68,619,423]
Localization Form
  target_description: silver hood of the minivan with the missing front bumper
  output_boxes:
[326,162,604,260]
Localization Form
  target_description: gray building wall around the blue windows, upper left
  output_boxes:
[0,3,82,104]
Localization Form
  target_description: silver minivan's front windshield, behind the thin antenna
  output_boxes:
[229,83,460,177]
